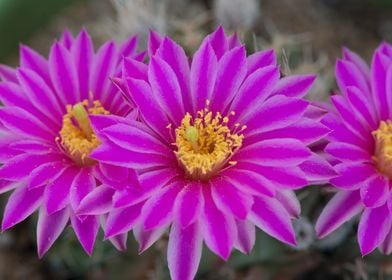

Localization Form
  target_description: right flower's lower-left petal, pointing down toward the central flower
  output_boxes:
[316,191,363,238]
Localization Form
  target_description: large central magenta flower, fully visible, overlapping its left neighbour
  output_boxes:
[89,28,334,279]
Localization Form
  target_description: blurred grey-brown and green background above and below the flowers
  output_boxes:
[0,0,392,280]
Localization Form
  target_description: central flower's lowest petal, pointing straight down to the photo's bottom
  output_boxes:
[167,223,203,280]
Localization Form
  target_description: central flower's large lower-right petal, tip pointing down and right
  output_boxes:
[249,197,296,245]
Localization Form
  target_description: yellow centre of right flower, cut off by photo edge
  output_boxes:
[372,120,392,178]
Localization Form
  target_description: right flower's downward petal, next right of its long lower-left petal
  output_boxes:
[358,204,392,256]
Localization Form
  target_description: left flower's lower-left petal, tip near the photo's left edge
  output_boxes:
[1,186,44,231]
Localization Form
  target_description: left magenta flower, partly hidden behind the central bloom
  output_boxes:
[0,31,142,256]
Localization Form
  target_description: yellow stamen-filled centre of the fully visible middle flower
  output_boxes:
[174,108,246,181]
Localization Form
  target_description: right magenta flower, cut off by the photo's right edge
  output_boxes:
[316,43,392,255]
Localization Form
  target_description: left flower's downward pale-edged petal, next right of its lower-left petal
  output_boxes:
[37,207,70,258]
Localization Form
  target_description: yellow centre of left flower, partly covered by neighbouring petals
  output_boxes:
[57,100,110,166]
